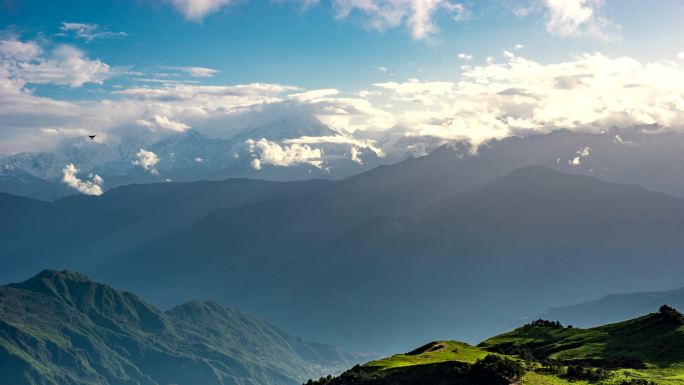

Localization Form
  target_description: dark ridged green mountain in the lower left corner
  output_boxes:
[0,270,357,385]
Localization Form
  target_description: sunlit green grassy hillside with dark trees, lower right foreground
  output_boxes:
[308,306,684,385]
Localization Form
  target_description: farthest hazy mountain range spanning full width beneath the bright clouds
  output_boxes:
[0,123,684,200]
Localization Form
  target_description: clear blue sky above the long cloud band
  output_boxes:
[5,0,684,88]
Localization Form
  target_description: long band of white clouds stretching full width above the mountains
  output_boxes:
[0,35,684,171]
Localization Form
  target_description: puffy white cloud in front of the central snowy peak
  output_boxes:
[245,138,323,170]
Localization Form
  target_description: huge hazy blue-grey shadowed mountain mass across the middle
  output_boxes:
[0,132,684,352]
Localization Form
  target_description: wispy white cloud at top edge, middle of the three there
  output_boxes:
[333,0,470,40]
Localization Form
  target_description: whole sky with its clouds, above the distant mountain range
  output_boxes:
[0,0,684,155]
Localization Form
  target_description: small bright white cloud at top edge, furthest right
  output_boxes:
[544,0,620,40]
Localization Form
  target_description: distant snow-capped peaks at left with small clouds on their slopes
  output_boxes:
[0,117,383,199]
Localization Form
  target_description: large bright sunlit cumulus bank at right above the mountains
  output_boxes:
[374,54,684,145]
